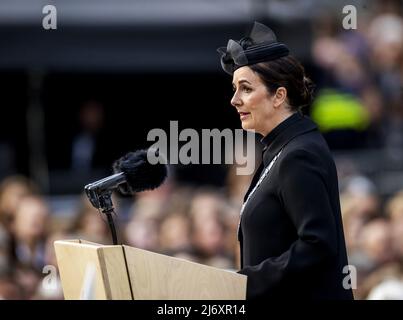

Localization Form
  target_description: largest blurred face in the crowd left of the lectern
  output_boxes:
[13,197,48,241]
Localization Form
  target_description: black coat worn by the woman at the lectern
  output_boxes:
[238,113,353,299]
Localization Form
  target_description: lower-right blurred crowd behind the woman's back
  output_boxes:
[341,176,403,300]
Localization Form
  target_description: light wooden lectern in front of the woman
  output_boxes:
[55,240,247,300]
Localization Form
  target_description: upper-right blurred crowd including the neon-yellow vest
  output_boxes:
[310,0,403,155]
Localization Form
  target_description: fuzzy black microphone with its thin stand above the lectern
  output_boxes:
[84,149,168,244]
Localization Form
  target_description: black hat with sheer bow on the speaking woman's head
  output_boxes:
[217,22,290,75]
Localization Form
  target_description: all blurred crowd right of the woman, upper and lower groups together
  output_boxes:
[310,0,403,299]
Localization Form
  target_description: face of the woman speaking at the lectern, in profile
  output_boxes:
[231,66,275,135]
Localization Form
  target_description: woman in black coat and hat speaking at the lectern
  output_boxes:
[218,23,353,299]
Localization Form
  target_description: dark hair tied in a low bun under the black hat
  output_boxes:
[249,56,314,111]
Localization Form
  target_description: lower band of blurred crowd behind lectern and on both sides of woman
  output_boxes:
[0,171,403,299]
